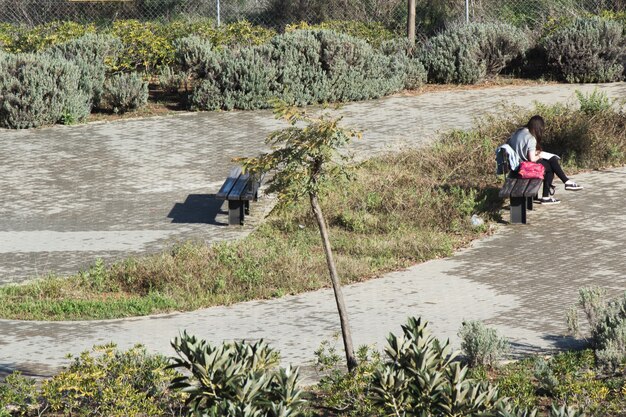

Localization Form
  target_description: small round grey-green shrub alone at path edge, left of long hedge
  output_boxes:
[102,73,148,113]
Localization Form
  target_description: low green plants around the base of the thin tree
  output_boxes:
[315,340,382,417]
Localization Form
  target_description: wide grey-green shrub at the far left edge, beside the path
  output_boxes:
[0,54,91,129]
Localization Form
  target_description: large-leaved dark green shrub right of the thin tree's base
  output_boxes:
[371,318,503,417]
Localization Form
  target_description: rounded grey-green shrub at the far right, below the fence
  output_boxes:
[542,18,626,83]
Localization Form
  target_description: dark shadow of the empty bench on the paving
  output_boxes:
[167,194,228,226]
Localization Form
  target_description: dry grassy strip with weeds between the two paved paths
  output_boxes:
[0,99,626,320]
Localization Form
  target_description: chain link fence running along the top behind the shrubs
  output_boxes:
[0,0,626,29]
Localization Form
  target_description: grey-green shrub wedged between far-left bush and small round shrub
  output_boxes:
[47,34,121,107]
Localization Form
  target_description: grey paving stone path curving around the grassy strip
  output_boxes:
[0,83,626,375]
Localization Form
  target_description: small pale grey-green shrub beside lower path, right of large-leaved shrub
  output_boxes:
[459,321,510,367]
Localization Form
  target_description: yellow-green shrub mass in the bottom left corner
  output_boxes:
[0,344,187,417]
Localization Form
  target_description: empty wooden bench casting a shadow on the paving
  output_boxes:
[215,167,262,226]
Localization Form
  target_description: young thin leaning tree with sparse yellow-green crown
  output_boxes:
[237,102,361,371]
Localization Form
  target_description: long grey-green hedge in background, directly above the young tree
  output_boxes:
[188,30,426,110]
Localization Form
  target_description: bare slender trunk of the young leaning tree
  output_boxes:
[309,193,357,371]
